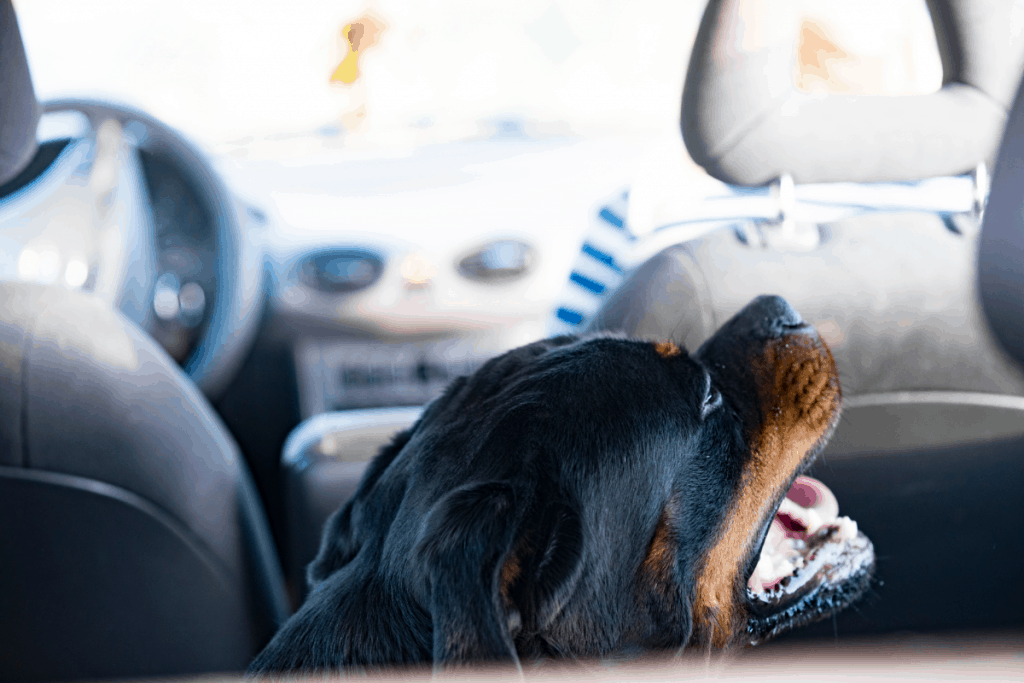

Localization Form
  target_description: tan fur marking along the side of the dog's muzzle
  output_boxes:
[693,335,841,647]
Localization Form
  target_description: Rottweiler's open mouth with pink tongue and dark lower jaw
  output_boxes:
[746,476,874,644]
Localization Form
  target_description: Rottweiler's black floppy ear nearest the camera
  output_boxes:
[416,481,518,667]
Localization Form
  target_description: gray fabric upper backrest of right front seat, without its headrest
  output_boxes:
[589,213,1024,396]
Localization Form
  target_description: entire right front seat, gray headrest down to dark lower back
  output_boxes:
[589,0,1024,637]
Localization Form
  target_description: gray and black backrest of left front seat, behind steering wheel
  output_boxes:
[0,283,288,681]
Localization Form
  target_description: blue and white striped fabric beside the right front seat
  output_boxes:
[547,193,636,336]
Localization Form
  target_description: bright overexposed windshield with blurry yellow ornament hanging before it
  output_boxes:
[15,0,941,158]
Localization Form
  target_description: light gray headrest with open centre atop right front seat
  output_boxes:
[681,0,1024,185]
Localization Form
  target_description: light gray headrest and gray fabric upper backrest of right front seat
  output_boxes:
[590,0,1024,396]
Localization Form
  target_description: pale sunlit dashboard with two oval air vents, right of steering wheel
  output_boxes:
[238,138,642,418]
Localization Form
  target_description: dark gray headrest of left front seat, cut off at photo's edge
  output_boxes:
[0,0,40,185]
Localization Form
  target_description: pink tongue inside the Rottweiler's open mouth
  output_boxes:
[748,476,857,593]
